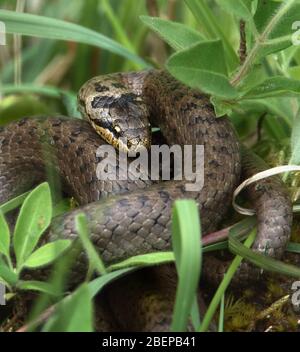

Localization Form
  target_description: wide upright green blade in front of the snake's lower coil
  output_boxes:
[171,200,202,332]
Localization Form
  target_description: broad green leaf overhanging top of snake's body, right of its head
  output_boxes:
[166,40,238,99]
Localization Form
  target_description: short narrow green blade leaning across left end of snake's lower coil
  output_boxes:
[75,213,106,275]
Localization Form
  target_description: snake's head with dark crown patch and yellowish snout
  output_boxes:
[78,76,151,153]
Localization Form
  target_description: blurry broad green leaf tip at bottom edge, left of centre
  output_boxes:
[43,283,93,332]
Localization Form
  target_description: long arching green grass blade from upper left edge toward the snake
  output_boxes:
[0,10,148,67]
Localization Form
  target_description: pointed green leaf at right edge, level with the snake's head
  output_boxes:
[243,76,300,99]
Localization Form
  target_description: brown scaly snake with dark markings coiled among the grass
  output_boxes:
[0,70,292,330]
